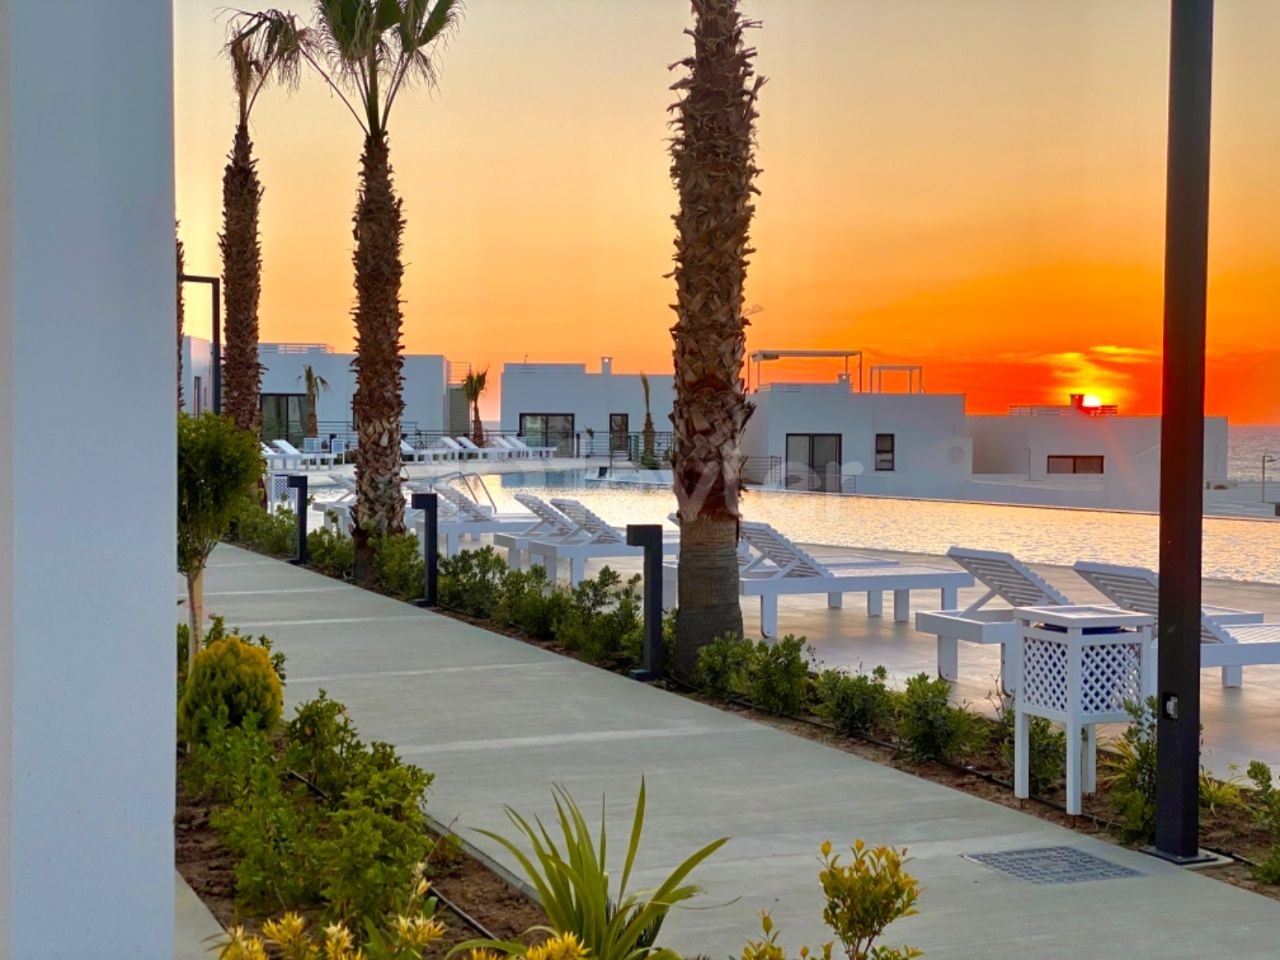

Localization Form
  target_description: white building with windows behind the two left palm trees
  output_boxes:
[183,337,466,440]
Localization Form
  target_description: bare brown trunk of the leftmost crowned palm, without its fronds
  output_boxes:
[218,122,262,435]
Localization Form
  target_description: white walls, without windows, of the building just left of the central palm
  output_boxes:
[502,364,675,439]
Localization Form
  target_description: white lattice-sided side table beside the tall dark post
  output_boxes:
[1014,607,1156,814]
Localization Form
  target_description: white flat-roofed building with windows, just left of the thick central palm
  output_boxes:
[502,357,675,449]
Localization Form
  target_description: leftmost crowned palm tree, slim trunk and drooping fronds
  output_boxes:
[218,10,310,436]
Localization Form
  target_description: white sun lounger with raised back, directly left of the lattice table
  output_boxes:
[915,547,1071,691]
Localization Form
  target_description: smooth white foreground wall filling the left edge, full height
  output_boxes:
[0,0,177,960]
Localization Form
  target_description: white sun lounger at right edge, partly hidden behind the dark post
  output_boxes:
[1073,561,1280,687]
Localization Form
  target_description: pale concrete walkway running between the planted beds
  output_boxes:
[194,547,1280,960]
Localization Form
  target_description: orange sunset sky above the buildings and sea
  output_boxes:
[174,0,1280,424]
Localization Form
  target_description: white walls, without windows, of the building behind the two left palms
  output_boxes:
[259,343,445,440]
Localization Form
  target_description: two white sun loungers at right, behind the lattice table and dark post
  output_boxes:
[915,547,1280,690]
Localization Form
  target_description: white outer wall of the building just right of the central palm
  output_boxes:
[742,384,970,497]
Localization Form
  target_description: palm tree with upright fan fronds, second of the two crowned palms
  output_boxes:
[291,0,461,579]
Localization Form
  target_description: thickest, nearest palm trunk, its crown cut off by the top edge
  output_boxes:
[671,0,764,676]
